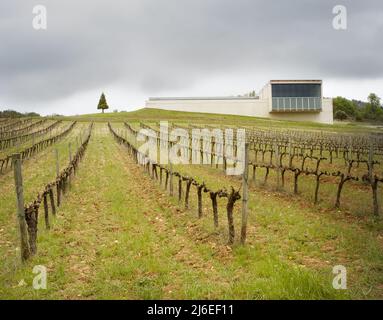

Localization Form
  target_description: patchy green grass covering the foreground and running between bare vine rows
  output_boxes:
[0,112,383,299]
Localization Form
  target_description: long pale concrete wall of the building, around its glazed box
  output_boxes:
[146,97,333,124]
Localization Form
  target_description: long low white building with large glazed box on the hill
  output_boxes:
[146,80,333,124]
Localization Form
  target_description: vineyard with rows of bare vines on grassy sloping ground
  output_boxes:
[0,111,383,299]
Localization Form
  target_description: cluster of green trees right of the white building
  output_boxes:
[333,93,383,121]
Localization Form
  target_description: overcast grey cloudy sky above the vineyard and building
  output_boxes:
[0,0,383,115]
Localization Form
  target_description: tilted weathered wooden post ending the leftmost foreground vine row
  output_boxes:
[12,153,31,262]
